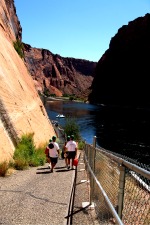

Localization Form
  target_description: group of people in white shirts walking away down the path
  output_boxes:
[45,135,77,173]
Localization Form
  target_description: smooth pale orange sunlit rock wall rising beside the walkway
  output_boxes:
[0,0,55,162]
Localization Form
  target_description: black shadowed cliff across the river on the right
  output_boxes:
[89,14,150,106]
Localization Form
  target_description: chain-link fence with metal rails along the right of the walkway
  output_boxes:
[85,140,150,225]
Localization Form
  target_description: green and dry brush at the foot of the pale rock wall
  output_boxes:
[0,134,46,177]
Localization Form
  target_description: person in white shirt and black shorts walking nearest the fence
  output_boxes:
[66,135,77,169]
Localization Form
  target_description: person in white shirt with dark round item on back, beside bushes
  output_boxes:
[48,136,60,173]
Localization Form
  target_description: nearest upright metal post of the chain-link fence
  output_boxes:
[118,165,125,219]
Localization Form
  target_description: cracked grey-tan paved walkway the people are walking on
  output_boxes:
[0,160,75,225]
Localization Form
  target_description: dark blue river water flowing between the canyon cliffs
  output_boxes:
[45,100,150,165]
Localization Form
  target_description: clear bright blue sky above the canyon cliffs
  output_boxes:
[14,0,150,62]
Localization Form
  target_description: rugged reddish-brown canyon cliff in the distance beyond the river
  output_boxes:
[24,44,97,97]
